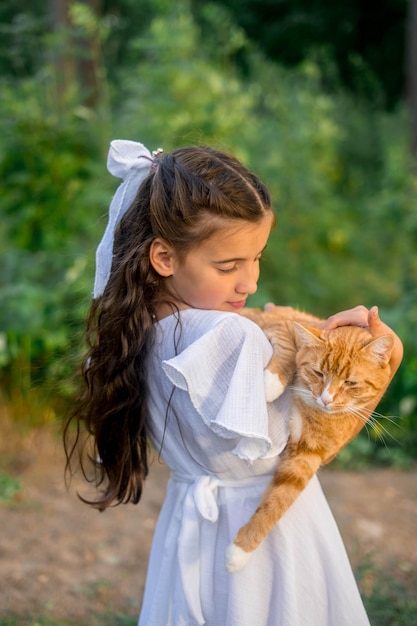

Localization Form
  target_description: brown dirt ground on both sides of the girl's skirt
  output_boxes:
[0,424,417,624]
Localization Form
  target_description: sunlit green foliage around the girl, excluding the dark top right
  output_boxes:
[0,0,417,458]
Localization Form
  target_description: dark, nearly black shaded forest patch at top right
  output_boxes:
[197,0,408,107]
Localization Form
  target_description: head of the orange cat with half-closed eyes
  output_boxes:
[293,322,394,414]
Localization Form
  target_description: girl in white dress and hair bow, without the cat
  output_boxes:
[66,141,402,626]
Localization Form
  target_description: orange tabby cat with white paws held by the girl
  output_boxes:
[226,307,394,573]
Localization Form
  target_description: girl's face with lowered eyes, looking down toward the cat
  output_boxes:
[154,212,273,313]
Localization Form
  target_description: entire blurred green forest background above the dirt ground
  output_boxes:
[0,0,417,467]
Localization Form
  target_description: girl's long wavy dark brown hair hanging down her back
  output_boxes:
[64,147,271,509]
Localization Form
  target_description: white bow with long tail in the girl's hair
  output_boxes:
[93,139,154,298]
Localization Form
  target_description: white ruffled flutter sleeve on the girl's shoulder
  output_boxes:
[162,315,272,461]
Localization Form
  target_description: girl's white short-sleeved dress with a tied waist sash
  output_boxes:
[139,309,369,626]
